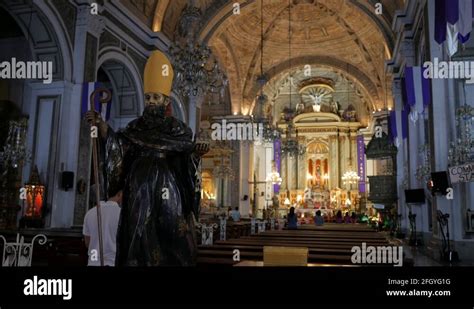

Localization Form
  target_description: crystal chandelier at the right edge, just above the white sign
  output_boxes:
[448,105,474,166]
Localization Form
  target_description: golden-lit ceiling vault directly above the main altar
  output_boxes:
[200,0,393,113]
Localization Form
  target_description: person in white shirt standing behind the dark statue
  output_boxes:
[82,191,122,266]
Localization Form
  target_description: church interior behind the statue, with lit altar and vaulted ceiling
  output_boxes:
[0,0,474,266]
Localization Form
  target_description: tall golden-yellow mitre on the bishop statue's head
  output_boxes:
[143,50,174,97]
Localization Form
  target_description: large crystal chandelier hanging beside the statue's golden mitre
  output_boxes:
[169,6,228,97]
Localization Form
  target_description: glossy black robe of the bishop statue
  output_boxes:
[105,116,200,266]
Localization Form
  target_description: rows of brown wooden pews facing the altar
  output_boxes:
[198,224,389,265]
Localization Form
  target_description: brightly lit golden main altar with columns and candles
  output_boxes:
[278,81,366,216]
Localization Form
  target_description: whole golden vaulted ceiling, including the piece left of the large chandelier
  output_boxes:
[122,0,406,118]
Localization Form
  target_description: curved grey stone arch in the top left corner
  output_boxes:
[0,0,73,81]
